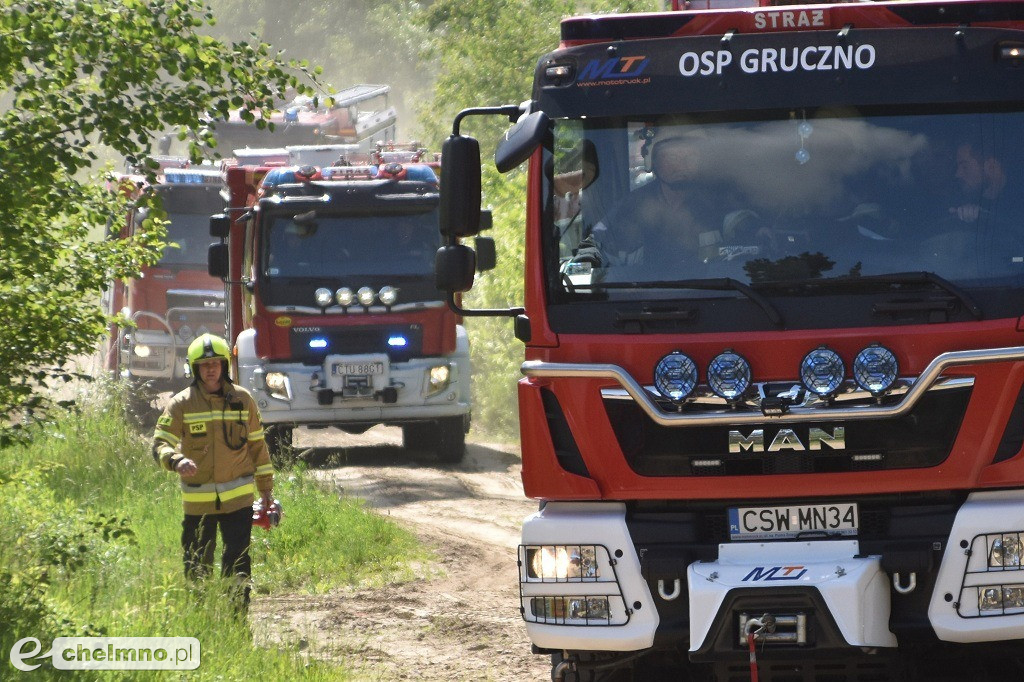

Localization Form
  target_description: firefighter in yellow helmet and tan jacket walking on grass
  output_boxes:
[153,334,273,608]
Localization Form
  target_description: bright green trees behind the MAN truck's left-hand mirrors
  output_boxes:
[420,0,664,437]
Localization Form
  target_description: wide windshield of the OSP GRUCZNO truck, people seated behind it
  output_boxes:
[545,106,1024,301]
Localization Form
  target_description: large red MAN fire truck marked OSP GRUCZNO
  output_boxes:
[437,0,1024,681]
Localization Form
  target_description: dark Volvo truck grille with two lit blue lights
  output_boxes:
[289,325,423,365]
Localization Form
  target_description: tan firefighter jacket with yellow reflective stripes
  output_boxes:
[153,381,273,515]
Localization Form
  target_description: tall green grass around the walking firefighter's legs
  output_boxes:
[0,378,424,680]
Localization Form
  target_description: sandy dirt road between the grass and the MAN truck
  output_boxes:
[254,427,550,682]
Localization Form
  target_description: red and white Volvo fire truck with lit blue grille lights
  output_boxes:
[210,151,487,462]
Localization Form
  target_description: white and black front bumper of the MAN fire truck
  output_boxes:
[520,489,1024,662]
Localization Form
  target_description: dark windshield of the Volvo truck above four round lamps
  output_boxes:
[263,208,440,281]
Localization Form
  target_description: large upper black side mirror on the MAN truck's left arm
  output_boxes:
[438,135,480,237]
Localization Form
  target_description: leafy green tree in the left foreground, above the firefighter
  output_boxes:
[0,0,316,443]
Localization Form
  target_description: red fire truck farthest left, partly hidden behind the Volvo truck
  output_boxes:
[103,157,224,395]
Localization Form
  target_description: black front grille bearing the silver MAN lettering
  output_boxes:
[604,387,971,476]
